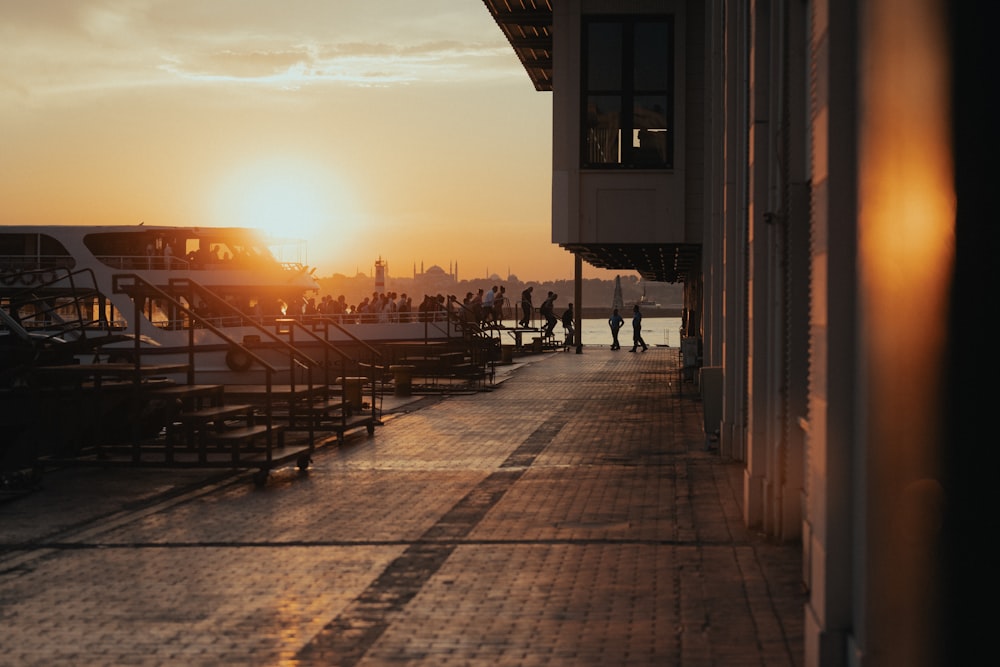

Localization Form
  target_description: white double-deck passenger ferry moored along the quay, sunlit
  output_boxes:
[0,225,452,383]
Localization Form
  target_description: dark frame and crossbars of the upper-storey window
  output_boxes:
[580,14,677,170]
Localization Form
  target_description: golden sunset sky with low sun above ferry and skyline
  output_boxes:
[0,0,613,280]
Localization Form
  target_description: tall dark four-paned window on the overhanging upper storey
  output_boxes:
[581,16,675,169]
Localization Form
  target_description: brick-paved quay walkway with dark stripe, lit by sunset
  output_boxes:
[0,348,805,667]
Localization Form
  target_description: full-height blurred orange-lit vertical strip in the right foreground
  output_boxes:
[858,0,955,665]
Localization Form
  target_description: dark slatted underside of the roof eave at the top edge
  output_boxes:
[483,0,552,91]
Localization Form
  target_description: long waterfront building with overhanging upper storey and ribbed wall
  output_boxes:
[484,0,984,666]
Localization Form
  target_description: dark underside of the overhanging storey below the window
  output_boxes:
[562,243,701,283]
